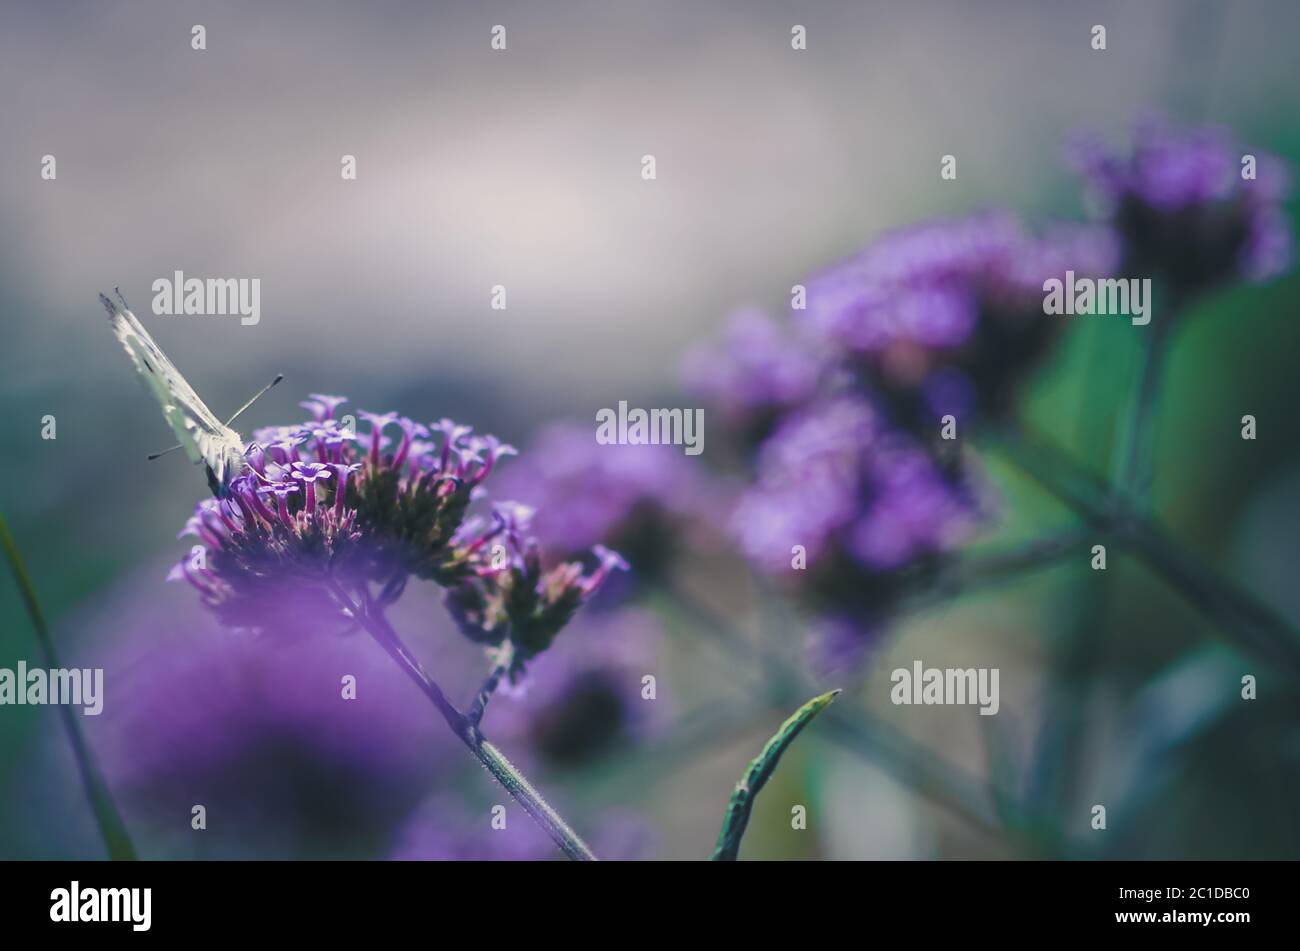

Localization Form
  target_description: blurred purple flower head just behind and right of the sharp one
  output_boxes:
[502,424,710,587]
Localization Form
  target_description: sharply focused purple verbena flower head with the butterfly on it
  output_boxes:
[172,395,621,669]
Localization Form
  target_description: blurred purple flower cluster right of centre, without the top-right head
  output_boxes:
[693,213,1097,659]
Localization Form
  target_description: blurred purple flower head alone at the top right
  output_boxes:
[1071,120,1292,291]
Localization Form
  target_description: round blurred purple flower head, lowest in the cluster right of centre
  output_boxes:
[732,395,988,649]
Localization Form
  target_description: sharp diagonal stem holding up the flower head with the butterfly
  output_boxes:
[330,581,595,861]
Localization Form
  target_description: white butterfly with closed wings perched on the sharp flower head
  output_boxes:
[99,291,283,496]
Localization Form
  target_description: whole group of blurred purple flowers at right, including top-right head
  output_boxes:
[685,123,1291,657]
